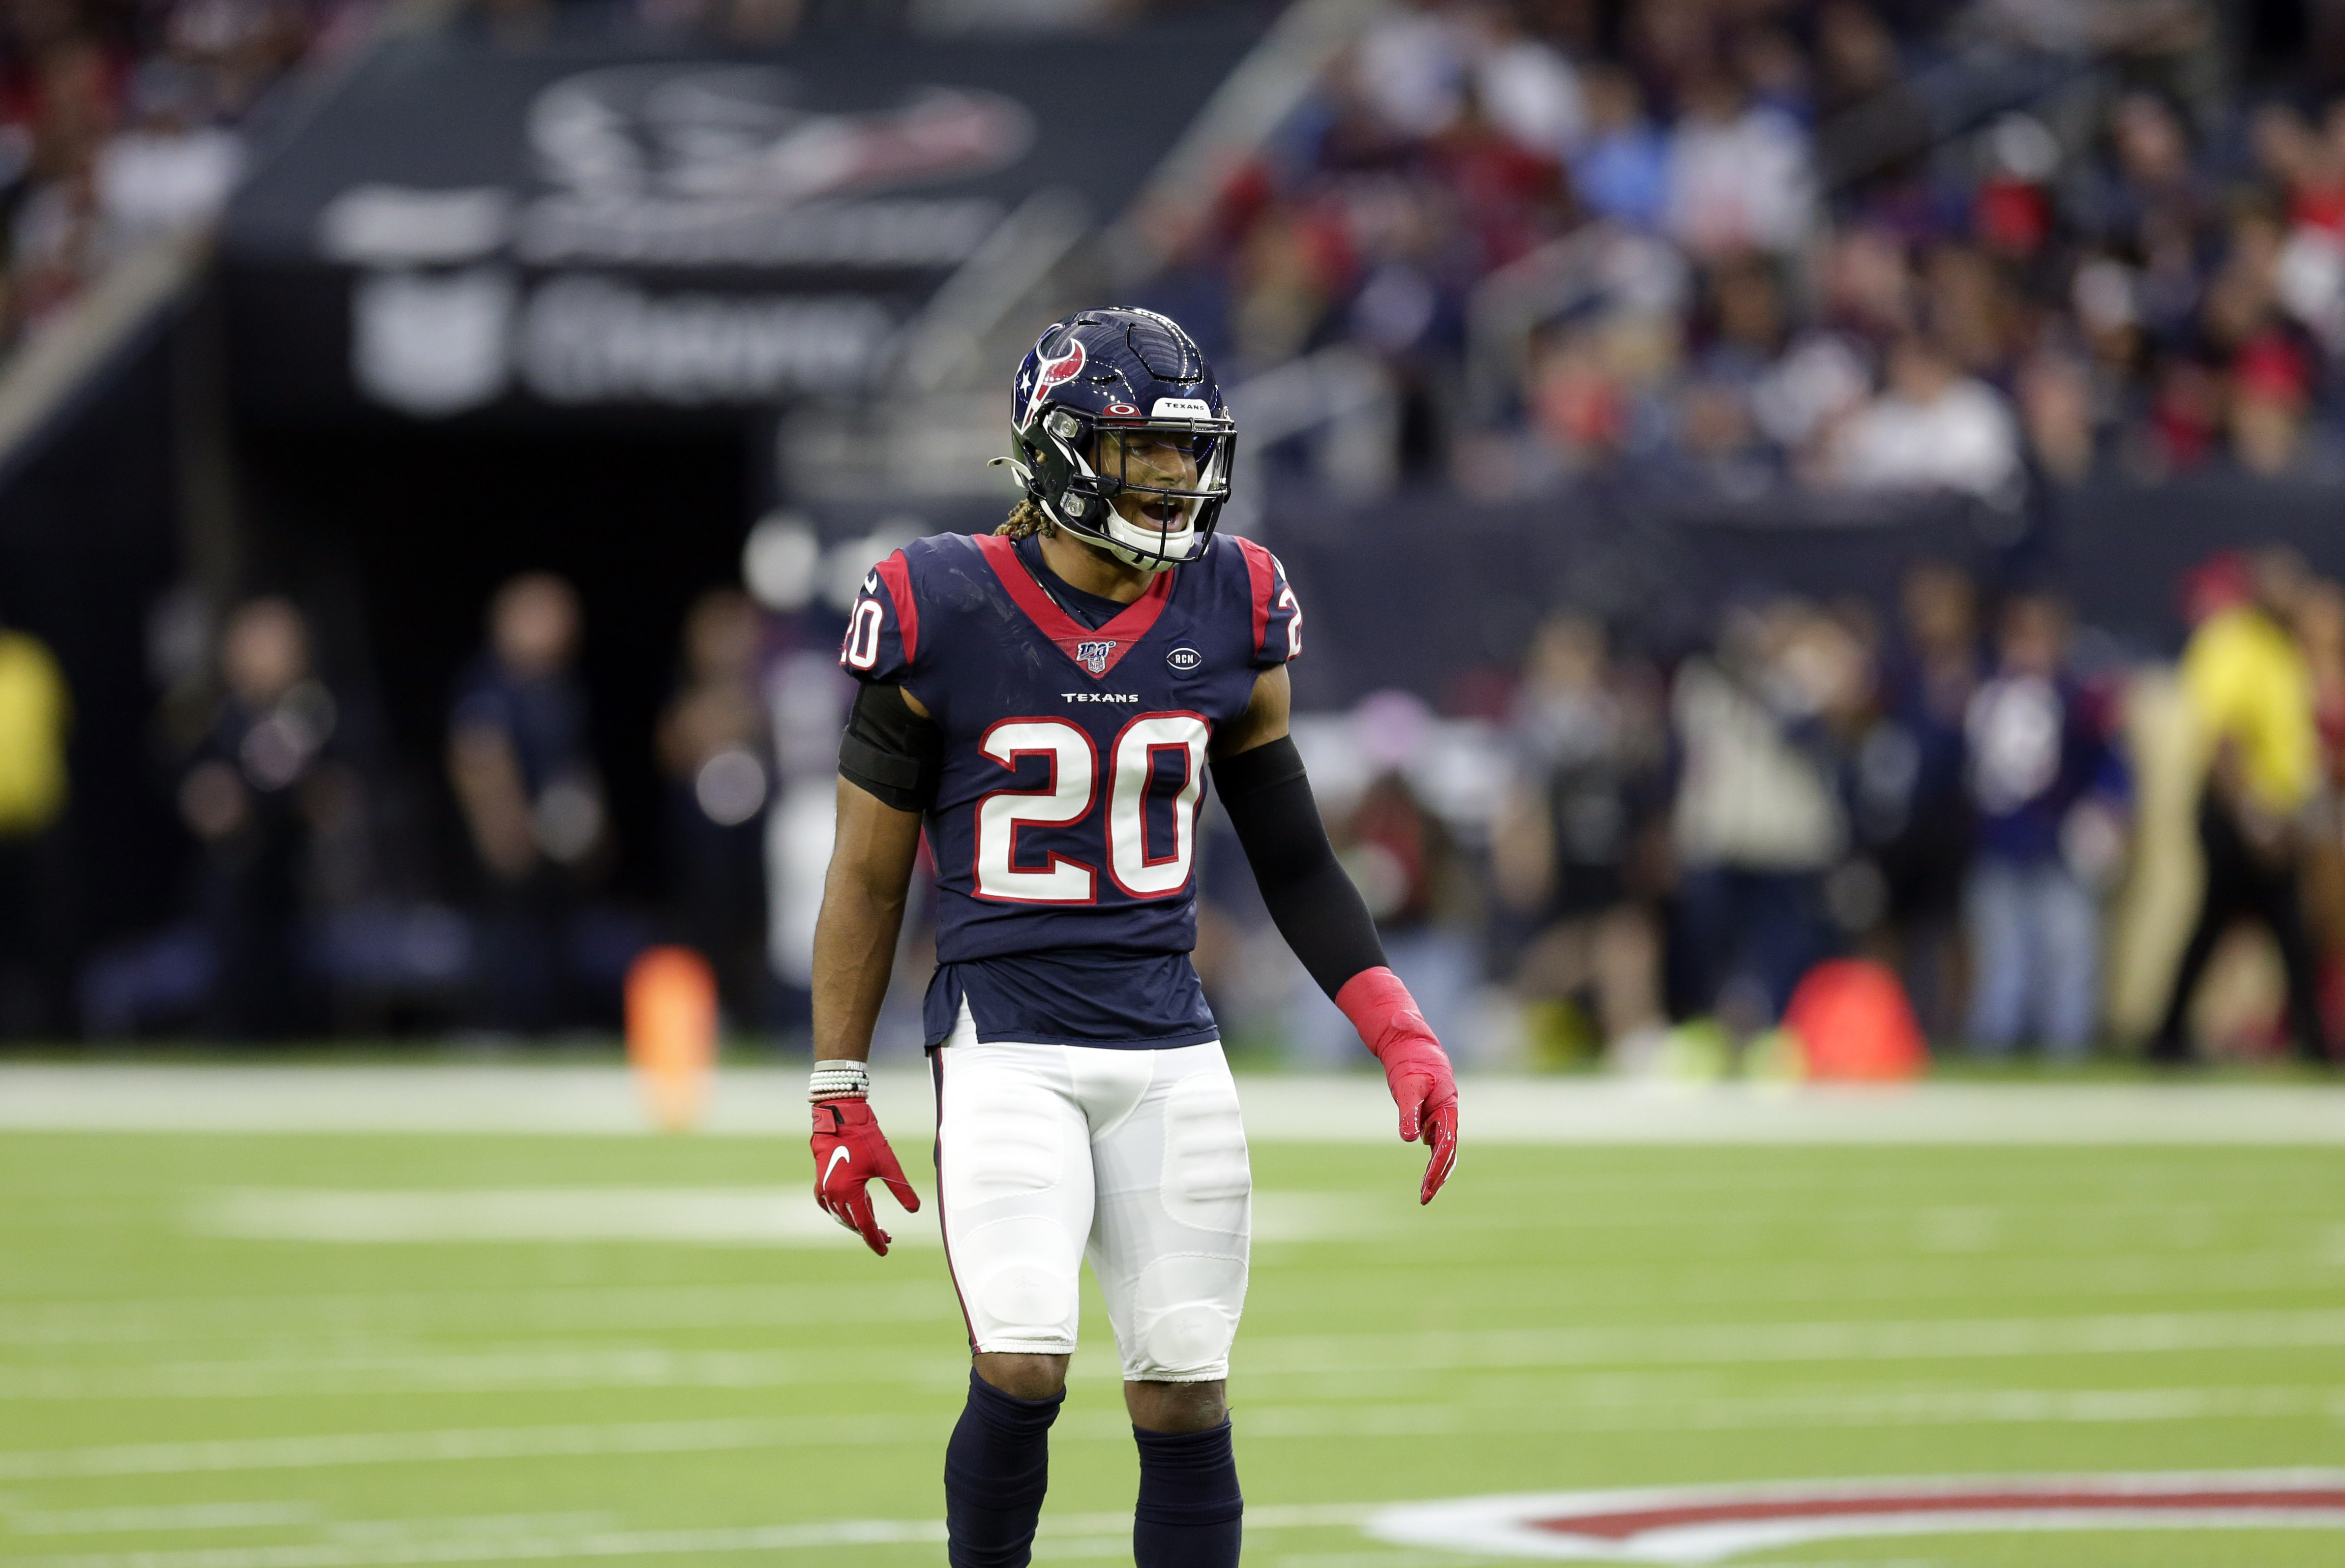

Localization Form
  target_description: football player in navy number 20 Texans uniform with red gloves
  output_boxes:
[811,310,1456,1568]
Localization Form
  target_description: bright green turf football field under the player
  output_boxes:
[0,1078,2345,1568]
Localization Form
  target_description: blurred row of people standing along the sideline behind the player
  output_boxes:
[0,523,2345,1066]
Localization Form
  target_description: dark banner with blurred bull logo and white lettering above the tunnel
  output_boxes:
[223,28,1252,422]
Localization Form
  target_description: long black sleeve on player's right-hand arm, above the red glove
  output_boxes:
[1212,736,1384,996]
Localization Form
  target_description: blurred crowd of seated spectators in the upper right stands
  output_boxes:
[1158,0,2345,499]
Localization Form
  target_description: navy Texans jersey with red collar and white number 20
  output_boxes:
[839,534,1302,1048]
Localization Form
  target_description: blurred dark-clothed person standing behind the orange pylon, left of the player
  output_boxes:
[659,588,771,1027]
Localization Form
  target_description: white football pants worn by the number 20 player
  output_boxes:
[931,1010,1254,1383]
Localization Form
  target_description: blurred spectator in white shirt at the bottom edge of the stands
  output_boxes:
[1834,335,2019,499]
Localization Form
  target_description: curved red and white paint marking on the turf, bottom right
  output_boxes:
[1367,1469,2345,1563]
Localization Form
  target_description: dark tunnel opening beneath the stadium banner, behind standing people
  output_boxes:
[239,422,765,904]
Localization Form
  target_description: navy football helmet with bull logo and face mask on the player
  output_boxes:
[994,305,1238,572]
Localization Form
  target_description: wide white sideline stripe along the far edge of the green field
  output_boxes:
[0,1064,2345,1146]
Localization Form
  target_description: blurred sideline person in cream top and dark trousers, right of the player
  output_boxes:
[1670,600,1862,1036]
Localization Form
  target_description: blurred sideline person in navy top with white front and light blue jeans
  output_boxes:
[1965,593,2124,1060]
